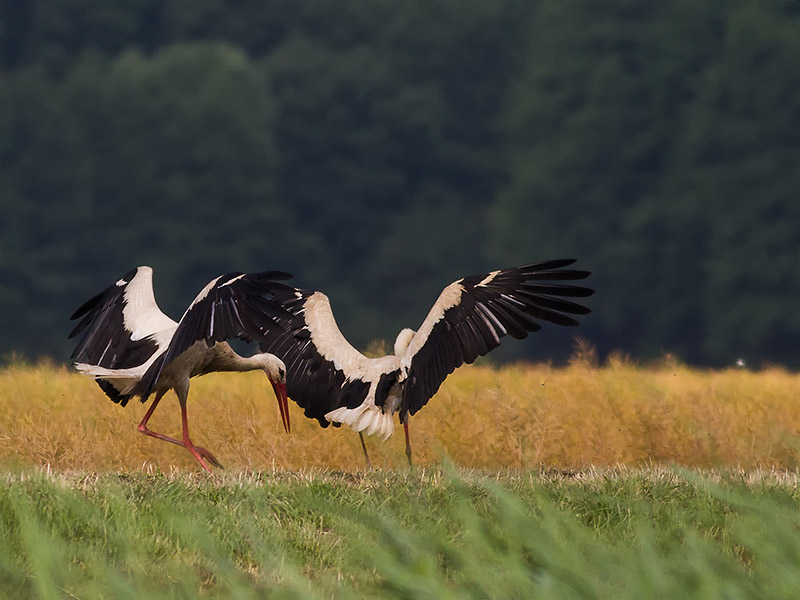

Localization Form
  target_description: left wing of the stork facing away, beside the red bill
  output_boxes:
[260,290,386,427]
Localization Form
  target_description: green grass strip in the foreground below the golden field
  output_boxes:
[0,468,800,600]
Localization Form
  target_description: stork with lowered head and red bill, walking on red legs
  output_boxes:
[69,267,293,472]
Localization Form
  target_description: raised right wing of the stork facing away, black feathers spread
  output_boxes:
[400,259,594,420]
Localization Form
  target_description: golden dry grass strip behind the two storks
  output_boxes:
[0,358,800,471]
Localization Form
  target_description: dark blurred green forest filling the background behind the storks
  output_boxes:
[0,0,800,367]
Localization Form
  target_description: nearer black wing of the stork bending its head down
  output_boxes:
[133,271,293,401]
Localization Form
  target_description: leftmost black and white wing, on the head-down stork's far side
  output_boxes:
[69,267,178,369]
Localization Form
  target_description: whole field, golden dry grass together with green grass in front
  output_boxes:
[0,357,800,600]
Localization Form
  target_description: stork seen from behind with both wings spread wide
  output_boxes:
[260,259,594,467]
